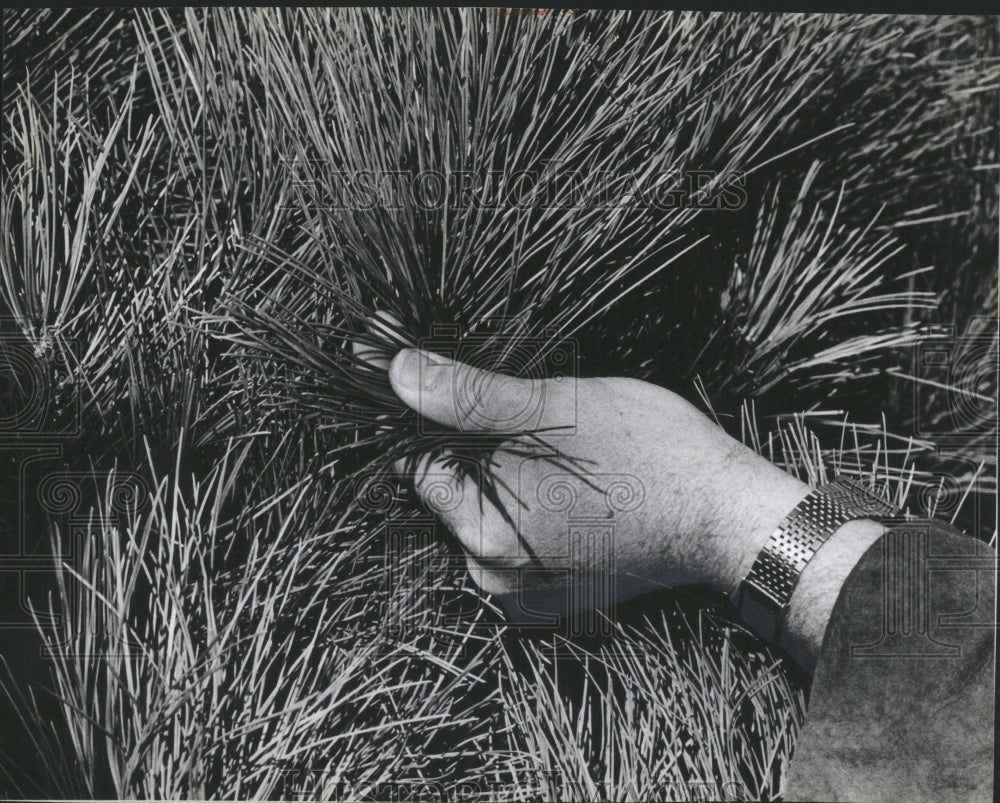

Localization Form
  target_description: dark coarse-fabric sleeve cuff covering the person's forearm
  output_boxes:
[785,520,996,803]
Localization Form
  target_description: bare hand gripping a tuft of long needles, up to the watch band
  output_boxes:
[356,326,809,616]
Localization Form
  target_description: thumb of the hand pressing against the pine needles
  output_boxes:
[389,349,544,432]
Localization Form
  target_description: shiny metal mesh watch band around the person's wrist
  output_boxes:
[736,477,898,644]
